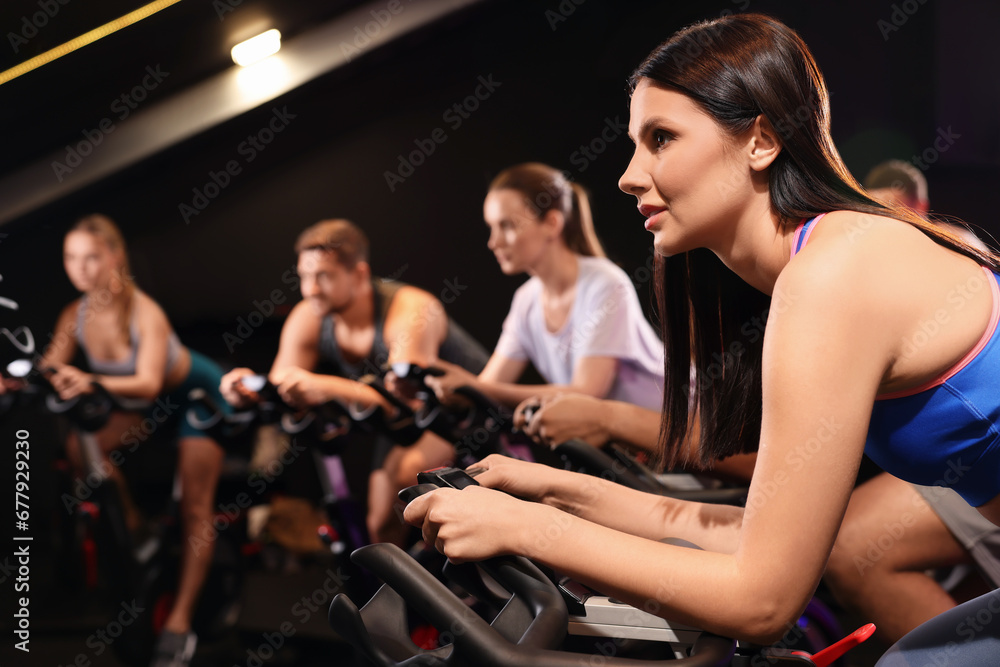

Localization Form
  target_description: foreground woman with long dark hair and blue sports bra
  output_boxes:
[405,14,1000,665]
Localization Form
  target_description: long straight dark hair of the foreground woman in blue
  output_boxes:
[629,14,1000,465]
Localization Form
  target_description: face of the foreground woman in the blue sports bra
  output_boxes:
[618,79,753,256]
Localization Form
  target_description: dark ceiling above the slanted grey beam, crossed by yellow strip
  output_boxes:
[0,0,365,174]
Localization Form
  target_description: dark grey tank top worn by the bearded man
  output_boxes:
[319,278,489,380]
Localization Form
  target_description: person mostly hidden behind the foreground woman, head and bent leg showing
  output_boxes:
[825,160,1000,643]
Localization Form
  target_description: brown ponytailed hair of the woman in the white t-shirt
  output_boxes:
[489,162,605,257]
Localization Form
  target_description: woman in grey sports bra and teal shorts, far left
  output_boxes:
[42,214,228,667]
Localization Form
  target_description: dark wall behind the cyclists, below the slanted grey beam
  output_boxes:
[0,0,1000,364]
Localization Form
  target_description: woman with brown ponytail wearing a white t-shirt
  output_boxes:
[429,163,663,408]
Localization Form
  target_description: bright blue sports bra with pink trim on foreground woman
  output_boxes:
[792,215,1000,507]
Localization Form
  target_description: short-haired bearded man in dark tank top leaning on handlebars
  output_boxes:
[221,220,488,541]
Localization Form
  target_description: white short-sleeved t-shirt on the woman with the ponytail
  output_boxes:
[496,257,663,410]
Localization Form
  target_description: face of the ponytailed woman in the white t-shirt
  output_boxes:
[483,189,552,275]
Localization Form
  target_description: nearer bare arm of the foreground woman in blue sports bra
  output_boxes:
[406,240,900,643]
